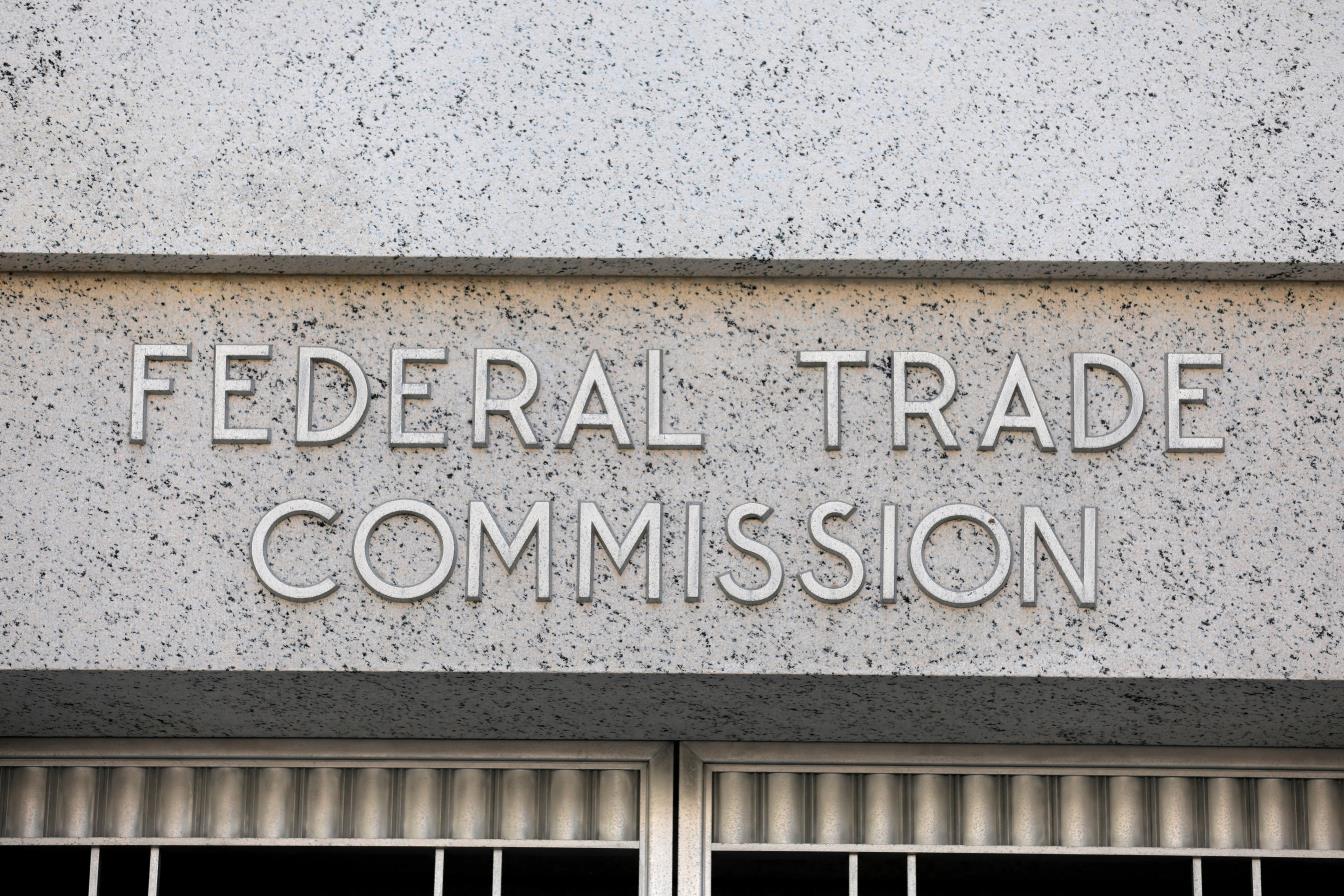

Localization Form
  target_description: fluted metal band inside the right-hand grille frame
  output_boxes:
[714,771,1344,850]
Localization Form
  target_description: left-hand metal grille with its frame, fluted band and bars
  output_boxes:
[0,740,672,896]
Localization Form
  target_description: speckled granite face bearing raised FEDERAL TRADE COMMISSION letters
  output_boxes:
[0,277,1344,678]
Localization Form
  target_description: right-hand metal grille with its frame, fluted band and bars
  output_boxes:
[677,743,1344,896]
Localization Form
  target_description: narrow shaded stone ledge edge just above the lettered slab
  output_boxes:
[0,253,1344,281]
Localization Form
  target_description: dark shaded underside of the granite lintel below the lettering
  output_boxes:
[0,669,1344,748]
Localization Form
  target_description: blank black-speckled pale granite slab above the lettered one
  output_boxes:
[0,0,1344,278]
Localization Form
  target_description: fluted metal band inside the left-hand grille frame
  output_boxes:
[0,766,640,844]
